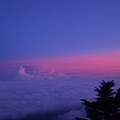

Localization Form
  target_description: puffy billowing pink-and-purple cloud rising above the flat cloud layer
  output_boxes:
[16,64,66,80]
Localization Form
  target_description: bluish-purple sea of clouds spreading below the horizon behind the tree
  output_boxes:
[0,79,120,120]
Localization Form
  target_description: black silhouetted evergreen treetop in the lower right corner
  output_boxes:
[75,80,120,120]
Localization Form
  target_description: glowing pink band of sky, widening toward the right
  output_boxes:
[0,51,120,77]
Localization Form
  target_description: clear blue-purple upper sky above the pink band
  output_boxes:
[0,0,120,79]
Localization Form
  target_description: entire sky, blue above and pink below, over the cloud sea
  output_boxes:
[0,0,120,79]
